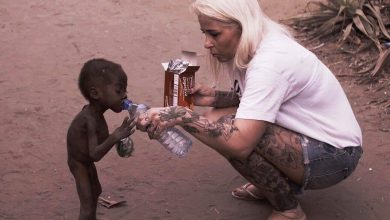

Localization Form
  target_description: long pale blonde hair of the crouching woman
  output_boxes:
[190,0,291,75]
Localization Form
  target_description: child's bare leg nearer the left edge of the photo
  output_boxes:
[69,162,96,220]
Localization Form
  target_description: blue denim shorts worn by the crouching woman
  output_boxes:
[298,135,363,191]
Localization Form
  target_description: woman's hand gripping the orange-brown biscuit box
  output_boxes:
[190,84,215,106]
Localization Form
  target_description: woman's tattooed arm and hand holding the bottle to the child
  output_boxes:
[137,106,267,160]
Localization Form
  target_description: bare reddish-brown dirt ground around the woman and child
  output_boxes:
[0,0,390,220]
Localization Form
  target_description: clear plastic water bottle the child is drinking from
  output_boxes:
[122,100,192,157]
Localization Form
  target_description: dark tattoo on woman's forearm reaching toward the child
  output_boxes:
[182,112,238,141]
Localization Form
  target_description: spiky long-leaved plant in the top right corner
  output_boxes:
[285,0,390,76]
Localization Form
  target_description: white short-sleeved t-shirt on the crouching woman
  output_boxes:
[232,33,362,148]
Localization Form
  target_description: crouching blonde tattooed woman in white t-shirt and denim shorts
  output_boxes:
[137,0,362,219]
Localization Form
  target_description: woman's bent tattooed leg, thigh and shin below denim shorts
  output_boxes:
[230,125,304,211]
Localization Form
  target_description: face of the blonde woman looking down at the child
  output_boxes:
[198,15,241,62]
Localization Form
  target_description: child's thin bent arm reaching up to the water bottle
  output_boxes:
[87,117,135,162]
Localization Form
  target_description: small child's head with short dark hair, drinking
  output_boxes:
[79,58,127,111]
